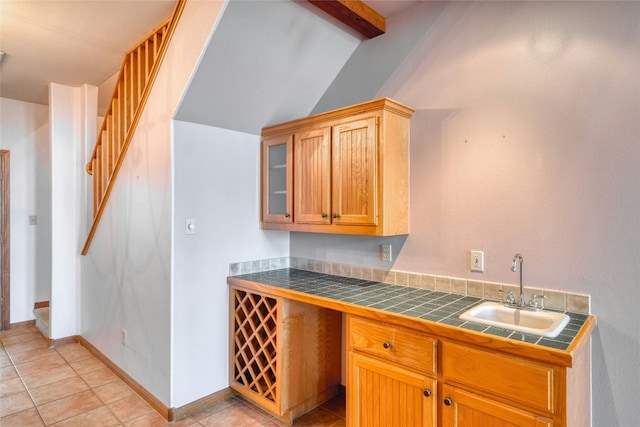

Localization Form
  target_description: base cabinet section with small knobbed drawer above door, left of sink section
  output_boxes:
[347,316,438,427]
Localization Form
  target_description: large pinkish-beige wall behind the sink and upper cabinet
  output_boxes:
[291,2,640,426]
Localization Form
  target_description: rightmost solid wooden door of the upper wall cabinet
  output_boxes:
[332,116,378,225]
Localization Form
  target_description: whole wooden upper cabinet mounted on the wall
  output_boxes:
[261,98,413,236]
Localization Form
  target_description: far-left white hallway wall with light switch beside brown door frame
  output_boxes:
[0,98,51,323]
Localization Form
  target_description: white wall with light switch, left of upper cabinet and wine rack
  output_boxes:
[173,121,289,407]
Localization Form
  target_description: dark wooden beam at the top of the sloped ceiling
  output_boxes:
[307,0,386,39]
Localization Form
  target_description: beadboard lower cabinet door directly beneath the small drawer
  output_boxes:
[347,351,437,427]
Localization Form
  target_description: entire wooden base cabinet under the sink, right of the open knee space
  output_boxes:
[347,315,590,427]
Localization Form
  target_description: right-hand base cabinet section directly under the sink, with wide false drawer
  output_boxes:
[438,337,591,427]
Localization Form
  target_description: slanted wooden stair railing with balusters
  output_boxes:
[82,0,186,255]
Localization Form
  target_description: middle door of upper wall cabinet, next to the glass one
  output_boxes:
[293,127,331,224]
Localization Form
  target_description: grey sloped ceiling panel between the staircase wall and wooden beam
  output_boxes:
[170,2,362,133]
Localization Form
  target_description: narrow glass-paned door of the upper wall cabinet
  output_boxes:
[262,134,293,224]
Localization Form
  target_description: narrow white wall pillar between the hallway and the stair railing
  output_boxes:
[49,83,98,339]
